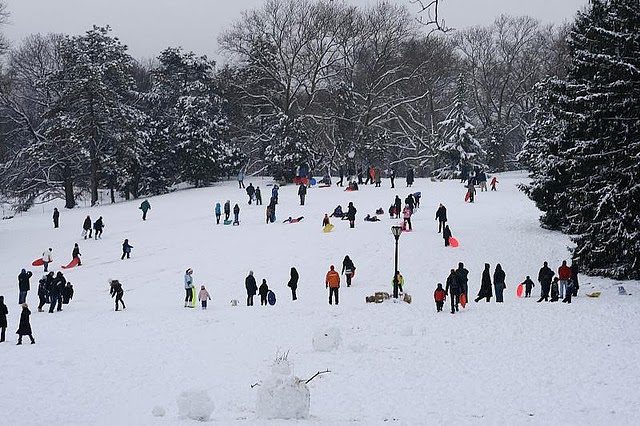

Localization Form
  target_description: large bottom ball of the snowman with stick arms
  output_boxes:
[256,374,311,419]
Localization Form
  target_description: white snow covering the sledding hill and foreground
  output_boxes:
[0,173,640,425]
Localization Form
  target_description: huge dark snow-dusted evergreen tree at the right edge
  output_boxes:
[531,0,640,279]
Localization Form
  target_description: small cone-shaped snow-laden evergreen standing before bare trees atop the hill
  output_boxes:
[434,74,483,178]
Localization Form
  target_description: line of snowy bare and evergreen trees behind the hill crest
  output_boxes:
[0,0,568,208]
